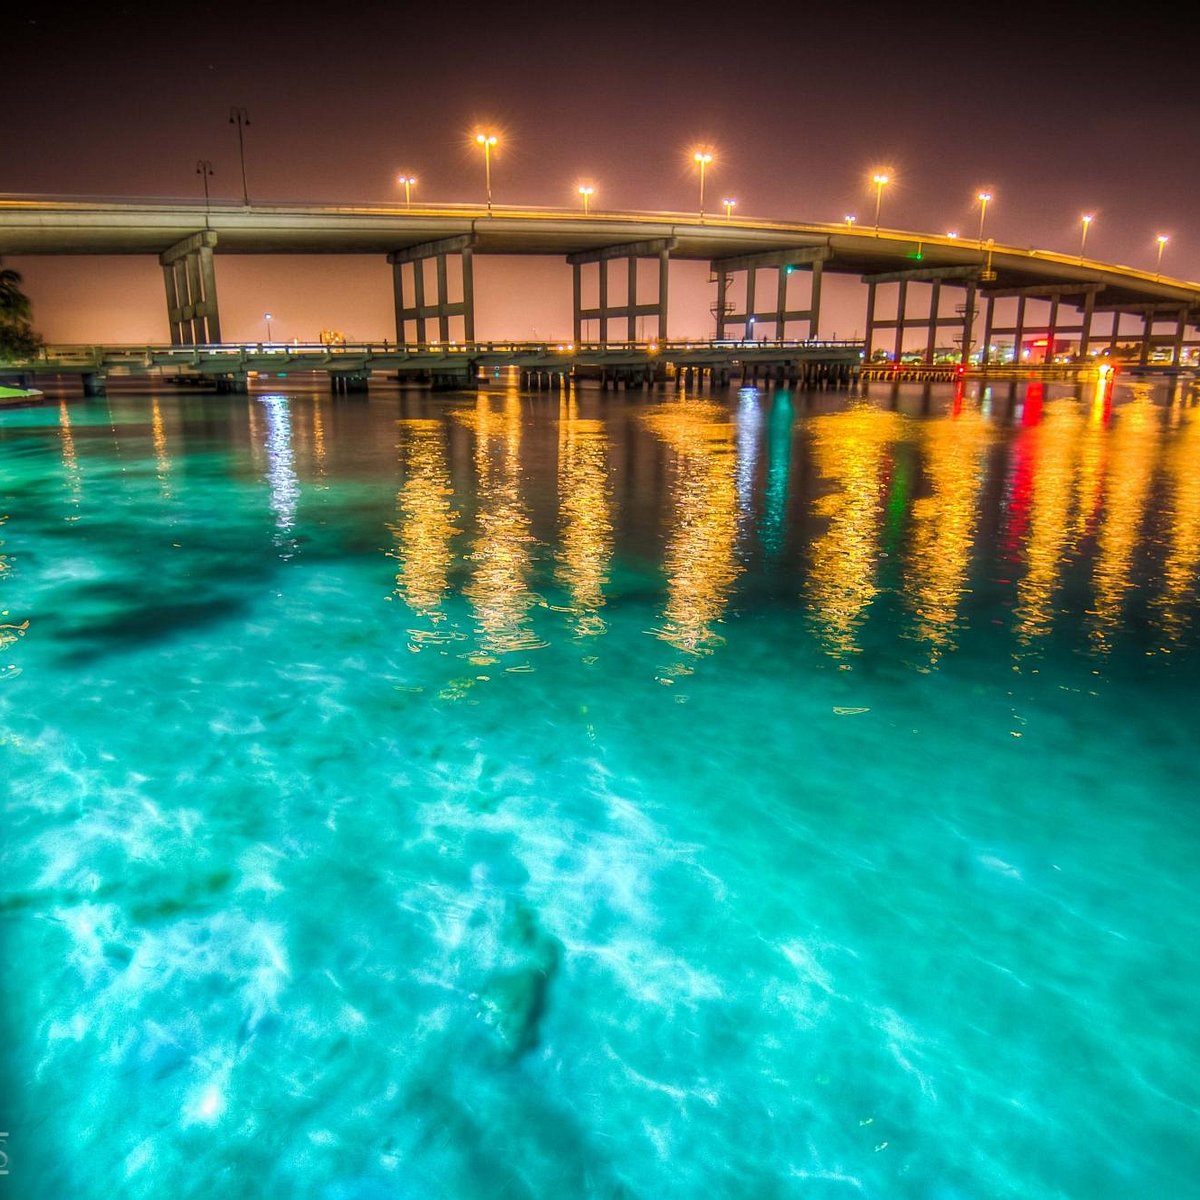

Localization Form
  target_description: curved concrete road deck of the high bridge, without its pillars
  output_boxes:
[0,194,1200,318]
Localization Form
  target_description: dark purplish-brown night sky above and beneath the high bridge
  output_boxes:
[0,2,1200,341]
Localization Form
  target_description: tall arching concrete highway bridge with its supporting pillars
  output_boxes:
[0,196,1200,370]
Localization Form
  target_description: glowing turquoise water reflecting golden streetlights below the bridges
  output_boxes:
[0,379,1200,1200]
